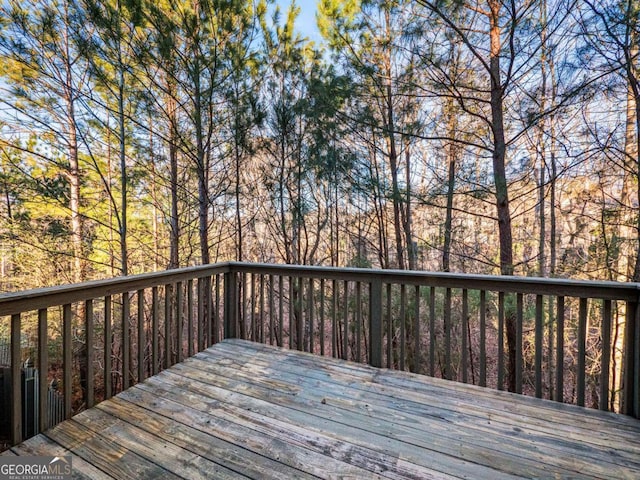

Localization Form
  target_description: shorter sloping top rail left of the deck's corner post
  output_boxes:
[0,263,229,316]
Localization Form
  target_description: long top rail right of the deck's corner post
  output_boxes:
[228,262,640,301]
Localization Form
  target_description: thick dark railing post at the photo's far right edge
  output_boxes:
[623,302,640,418]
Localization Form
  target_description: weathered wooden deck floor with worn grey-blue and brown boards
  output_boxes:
[5,340,640,480]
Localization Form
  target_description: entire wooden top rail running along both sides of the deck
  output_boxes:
[0,262,640,316]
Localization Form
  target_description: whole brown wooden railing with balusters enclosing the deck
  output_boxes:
[0,262,640,443]
